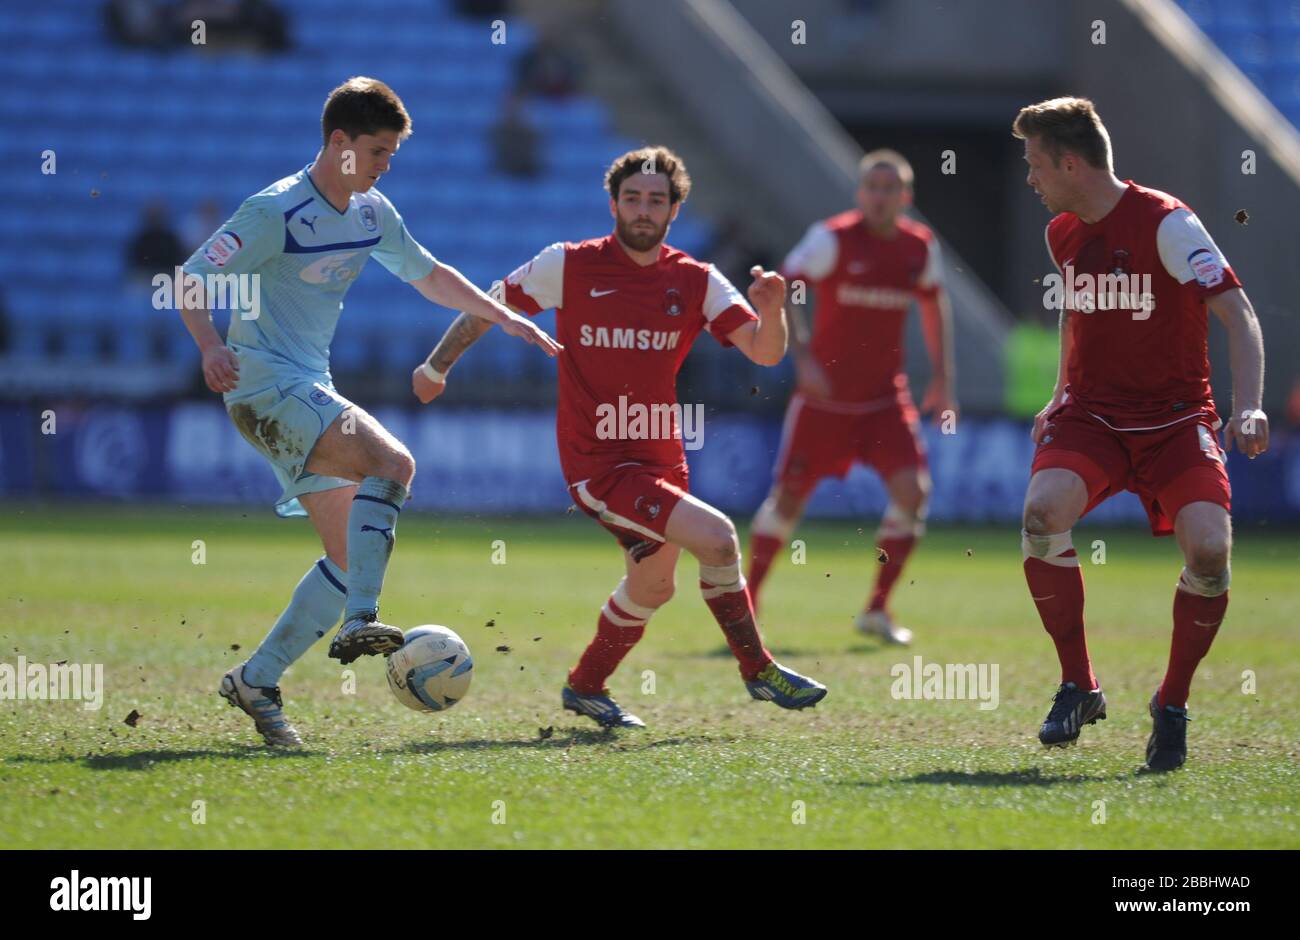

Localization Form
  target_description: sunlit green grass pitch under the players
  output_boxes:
[0,504,1300,848]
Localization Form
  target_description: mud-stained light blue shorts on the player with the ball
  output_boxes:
[222,343,355,516]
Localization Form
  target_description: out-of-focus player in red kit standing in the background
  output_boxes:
[749,150,957,644]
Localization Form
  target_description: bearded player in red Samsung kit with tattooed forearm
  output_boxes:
[412,147,827,727]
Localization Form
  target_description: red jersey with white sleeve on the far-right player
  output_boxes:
[1047,179,1242,430]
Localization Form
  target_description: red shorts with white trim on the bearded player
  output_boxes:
[569,463,690,562]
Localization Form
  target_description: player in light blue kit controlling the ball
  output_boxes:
[181,78,560,746]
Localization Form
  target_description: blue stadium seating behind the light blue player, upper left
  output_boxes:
[0,0,710,378]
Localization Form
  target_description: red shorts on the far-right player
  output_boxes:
[1032,400,1232,536]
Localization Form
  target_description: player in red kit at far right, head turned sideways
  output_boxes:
[1013,98,1269,771]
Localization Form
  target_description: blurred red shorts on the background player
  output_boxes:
[774,393,926,495]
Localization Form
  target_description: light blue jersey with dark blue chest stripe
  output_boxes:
[185,166,434,390]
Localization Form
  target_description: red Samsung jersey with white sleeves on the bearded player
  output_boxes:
[494,235,758,485]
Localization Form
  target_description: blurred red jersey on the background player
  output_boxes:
[781,209,940,406]
